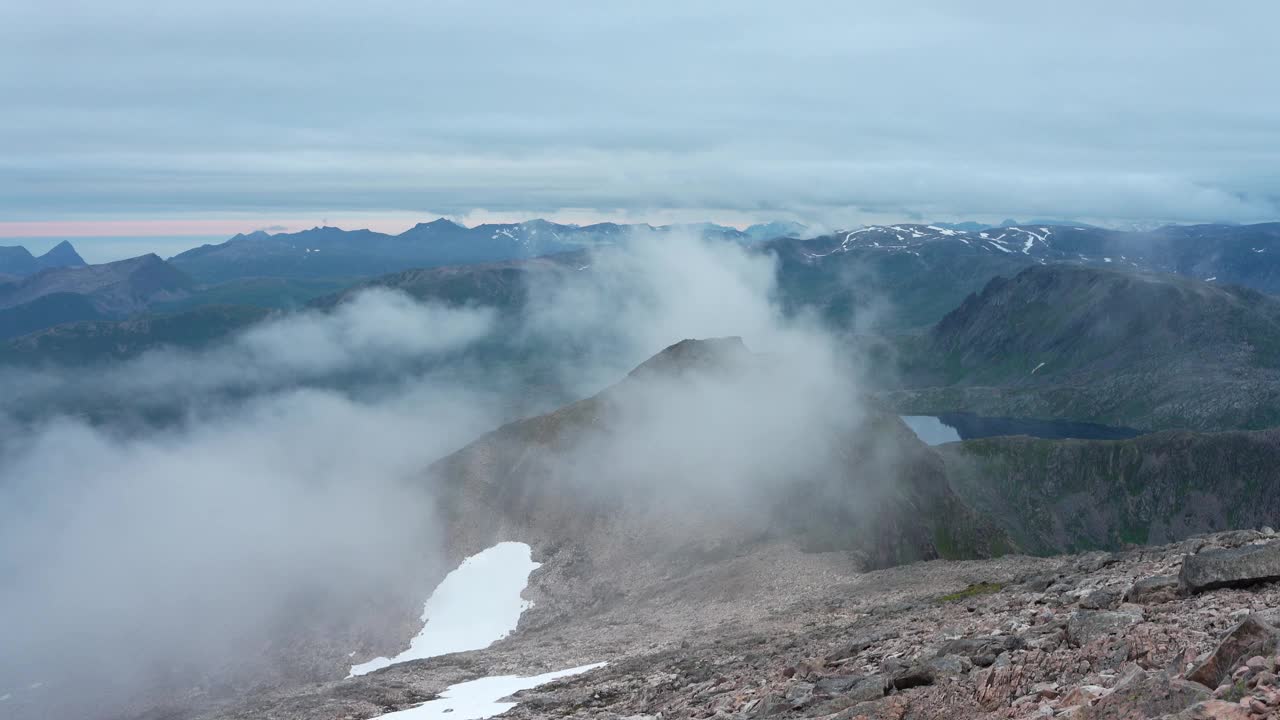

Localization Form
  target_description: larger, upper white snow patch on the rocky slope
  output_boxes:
[351,542,539,676]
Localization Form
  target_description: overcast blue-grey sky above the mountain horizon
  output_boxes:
[0,0,1280,255]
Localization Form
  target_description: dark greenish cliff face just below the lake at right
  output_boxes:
[937,429,1280,553]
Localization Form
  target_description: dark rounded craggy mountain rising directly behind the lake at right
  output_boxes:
[893,265,1280,429]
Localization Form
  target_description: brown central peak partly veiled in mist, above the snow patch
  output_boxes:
[430,338,1009,573]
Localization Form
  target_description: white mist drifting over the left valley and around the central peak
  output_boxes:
[0,230,880,716]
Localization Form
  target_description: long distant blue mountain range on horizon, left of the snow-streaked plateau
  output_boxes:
[170,218,778,283]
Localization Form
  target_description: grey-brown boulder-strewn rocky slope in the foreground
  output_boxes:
[197,520,1280,720]
